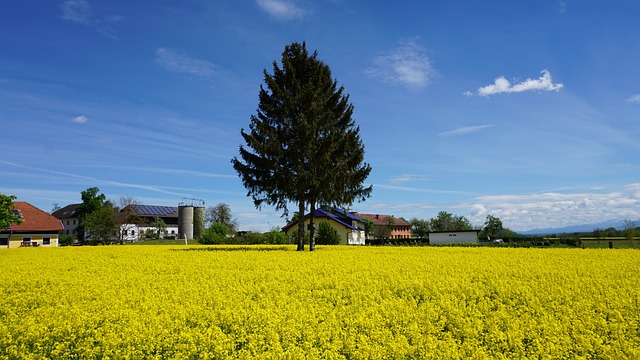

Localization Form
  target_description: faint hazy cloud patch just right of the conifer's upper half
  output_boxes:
[365,39,436,88]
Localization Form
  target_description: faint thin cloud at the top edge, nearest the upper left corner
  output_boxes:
[60,0,123,39]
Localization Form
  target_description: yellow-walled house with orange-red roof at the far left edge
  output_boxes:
[0,201,63,248]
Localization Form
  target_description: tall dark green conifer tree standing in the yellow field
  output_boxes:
[231,43,372,250]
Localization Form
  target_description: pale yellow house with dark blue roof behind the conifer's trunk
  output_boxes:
[282,207,366,245]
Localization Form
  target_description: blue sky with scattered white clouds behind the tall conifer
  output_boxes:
[0,0,640,231]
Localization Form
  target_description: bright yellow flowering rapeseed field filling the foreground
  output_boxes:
[0,246,640,359]
